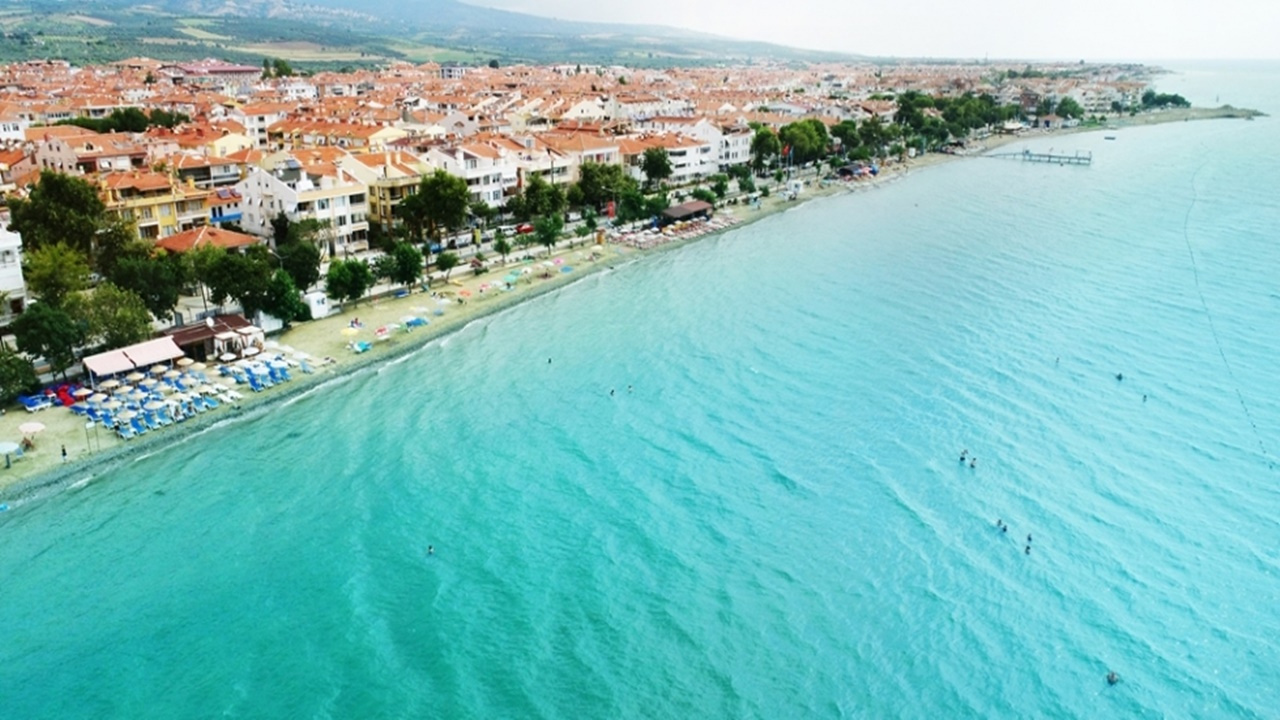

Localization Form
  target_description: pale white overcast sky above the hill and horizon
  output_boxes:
[465,0,1280,61]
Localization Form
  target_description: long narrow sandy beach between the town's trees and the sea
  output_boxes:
[0,109,1249,507]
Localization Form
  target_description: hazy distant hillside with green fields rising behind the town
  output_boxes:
[0,0,858,68]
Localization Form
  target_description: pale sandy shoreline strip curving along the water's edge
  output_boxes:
[0,106,1266,507]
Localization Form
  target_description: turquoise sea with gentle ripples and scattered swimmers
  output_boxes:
[0,64,1280,719]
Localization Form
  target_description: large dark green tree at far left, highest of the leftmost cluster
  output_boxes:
[9,170,106,258]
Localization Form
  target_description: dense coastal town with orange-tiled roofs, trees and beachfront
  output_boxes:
[0,58,1218,486]
